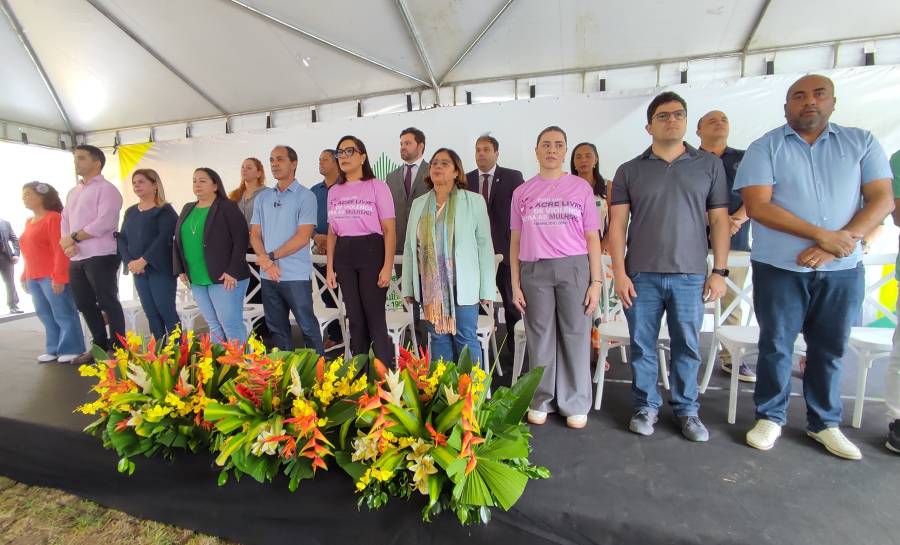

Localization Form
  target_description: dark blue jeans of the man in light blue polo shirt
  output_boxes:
[262,279,325,354]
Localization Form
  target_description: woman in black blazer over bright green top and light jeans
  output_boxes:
[174,168,250,343]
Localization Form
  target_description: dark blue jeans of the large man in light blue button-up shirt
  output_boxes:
[752,261,865,433]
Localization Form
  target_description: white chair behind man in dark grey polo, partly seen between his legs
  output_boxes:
[594,255,670,411]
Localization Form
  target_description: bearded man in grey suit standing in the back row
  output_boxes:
[385,127,429,255]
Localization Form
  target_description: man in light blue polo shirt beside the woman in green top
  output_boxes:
[250,146,324,354]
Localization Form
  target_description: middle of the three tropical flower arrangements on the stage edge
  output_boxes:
[203,349,368,491]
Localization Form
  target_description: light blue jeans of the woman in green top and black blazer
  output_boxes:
[191,278,250,343]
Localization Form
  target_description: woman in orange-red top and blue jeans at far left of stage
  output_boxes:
[19,182,85,363]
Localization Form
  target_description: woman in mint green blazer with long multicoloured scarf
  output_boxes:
[401,148,497,362]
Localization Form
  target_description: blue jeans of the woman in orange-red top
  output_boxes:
[28,278,85,356]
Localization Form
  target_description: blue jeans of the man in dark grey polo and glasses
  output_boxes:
[625,272,706,416]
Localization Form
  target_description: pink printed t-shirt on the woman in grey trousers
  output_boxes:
[509,174,600,261]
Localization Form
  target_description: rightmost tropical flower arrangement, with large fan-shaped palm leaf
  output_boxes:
[336,350,549,524]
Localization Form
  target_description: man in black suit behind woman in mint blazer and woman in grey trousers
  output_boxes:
[466,134,524,334]
